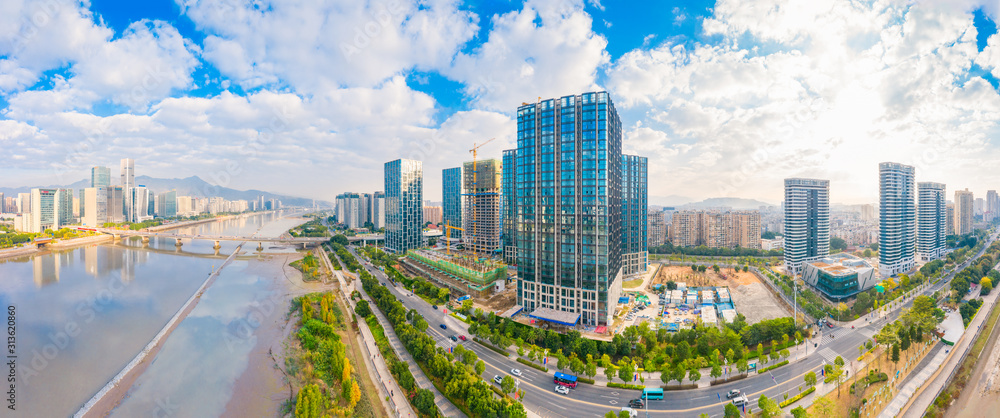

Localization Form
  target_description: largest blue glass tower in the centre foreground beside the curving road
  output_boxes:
[515,92,622,325]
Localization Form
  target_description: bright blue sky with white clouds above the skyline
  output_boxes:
[0,0,1000,204]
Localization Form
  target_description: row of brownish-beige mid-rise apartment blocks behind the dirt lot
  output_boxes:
[669,210,761,249]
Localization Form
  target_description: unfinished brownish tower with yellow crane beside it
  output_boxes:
[462,158,503,254]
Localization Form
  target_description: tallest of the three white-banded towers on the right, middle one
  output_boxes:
[880,163,916,277]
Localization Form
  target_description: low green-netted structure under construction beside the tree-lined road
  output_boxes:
[404,250,507,298]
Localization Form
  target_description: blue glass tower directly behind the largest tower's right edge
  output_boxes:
[622,155,648,275]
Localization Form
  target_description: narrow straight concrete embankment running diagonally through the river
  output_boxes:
[73,243,245,418]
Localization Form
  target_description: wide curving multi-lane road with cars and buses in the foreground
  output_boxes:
[349,229,997,417]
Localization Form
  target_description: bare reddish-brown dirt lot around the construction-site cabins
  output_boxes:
[653,266,792,324]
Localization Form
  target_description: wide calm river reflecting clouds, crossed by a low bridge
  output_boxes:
[0,213,303,417]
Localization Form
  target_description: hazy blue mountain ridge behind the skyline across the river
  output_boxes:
[0,176,324,207]
